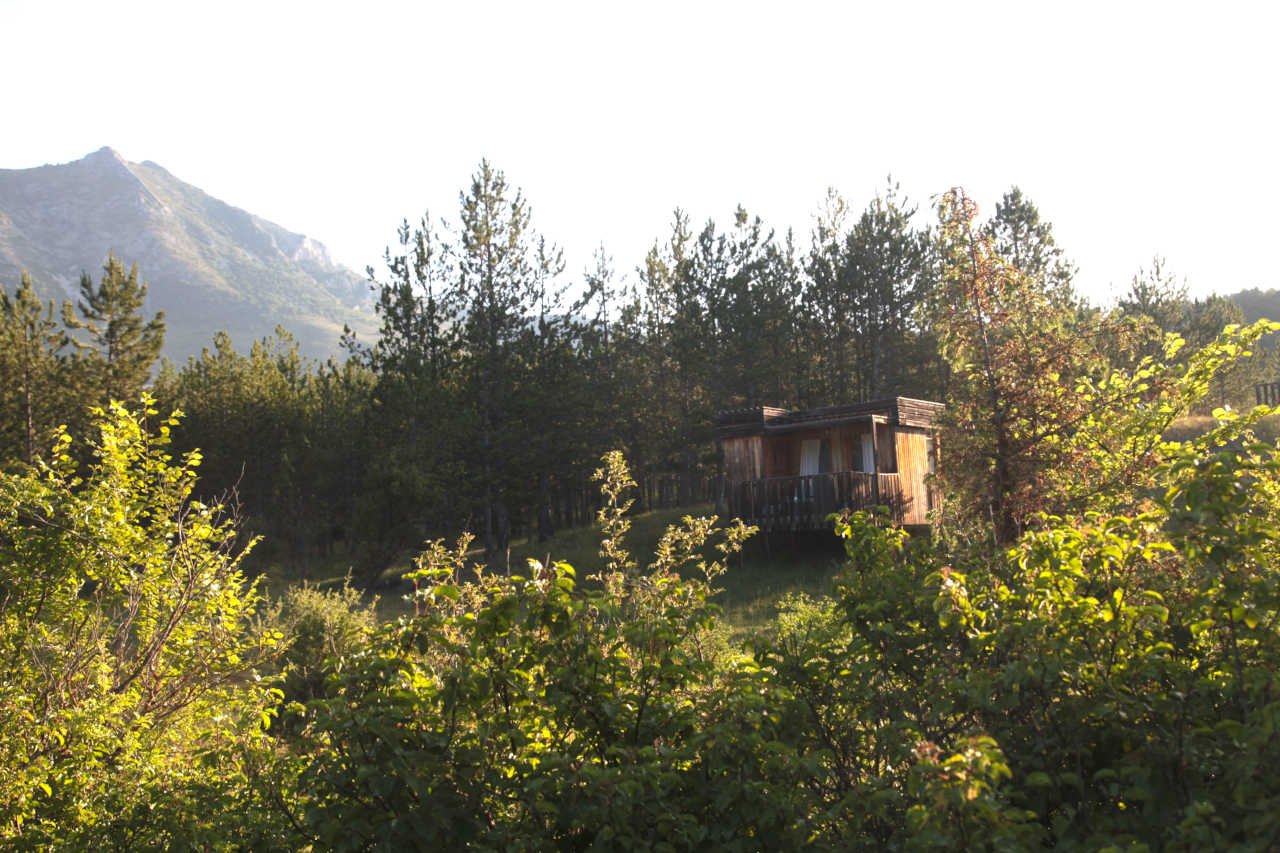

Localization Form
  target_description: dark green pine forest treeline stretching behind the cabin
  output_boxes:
[0,163,1267,579]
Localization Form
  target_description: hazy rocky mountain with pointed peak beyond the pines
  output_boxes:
[0,149,374,360]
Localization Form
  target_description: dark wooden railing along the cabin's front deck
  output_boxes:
[726,471,904,530]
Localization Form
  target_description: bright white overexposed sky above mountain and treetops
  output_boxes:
[0,0,1280,302]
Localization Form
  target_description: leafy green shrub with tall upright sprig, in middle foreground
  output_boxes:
[286,456,808,849]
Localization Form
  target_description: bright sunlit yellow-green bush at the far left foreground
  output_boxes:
[0,403,285,848]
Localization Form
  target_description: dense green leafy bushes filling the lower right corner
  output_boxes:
[759,425,1280,849]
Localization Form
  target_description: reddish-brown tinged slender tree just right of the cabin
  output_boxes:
[934,190,1106,546]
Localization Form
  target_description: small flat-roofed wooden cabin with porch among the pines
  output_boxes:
[716,397,942,532]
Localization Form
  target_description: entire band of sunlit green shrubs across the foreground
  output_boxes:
[0,322,1280,850]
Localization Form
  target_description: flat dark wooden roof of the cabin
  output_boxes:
[716,397,945,439]
